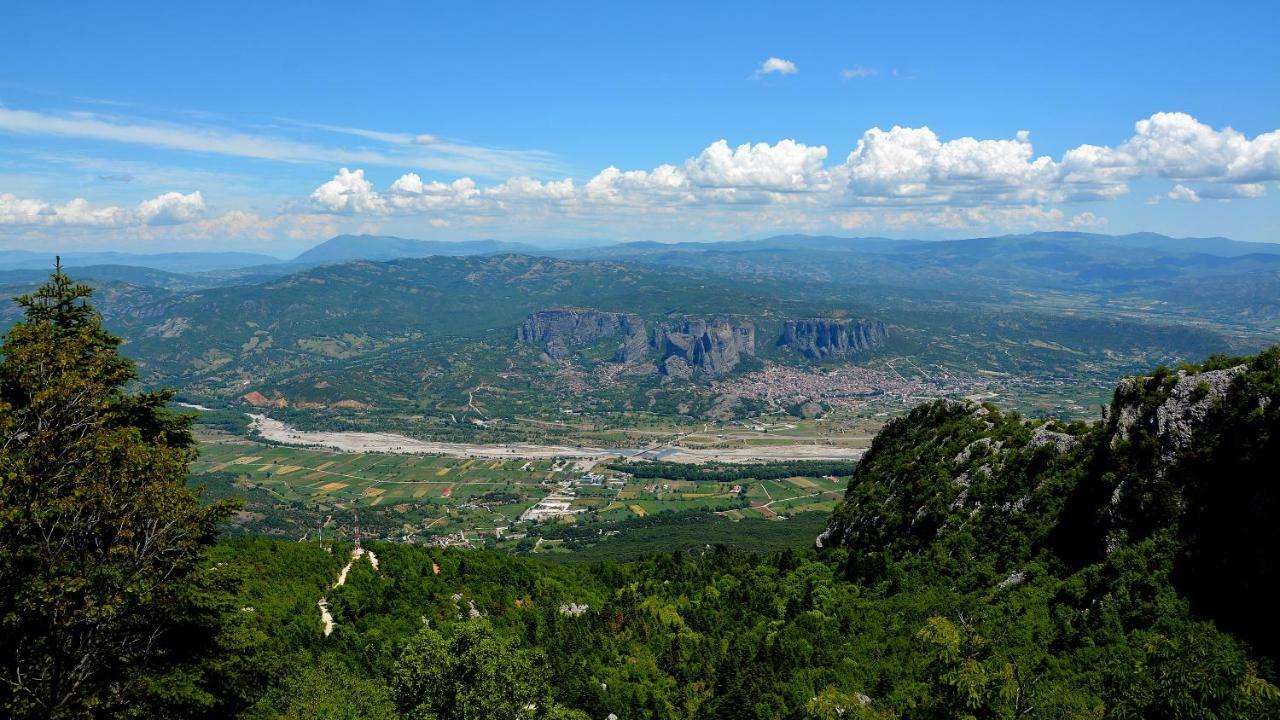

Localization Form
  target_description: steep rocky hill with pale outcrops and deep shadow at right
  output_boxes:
[818,347,1280,651]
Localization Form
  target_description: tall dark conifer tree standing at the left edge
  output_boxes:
[0,266,229,719]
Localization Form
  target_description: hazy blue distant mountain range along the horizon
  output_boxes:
[0,232,1280,275]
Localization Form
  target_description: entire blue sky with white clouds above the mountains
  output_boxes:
[0,0,1280,256]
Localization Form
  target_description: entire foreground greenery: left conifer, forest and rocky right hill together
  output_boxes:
[0,273,1280,720]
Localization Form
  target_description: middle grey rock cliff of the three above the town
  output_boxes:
[653,318,755,378]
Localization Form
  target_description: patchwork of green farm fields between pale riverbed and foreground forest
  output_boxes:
[191,434,844,550]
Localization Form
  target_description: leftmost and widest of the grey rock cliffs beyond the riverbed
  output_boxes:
[516,307,649,363]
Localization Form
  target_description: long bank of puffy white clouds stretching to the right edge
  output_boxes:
[264,113,1280,231]
